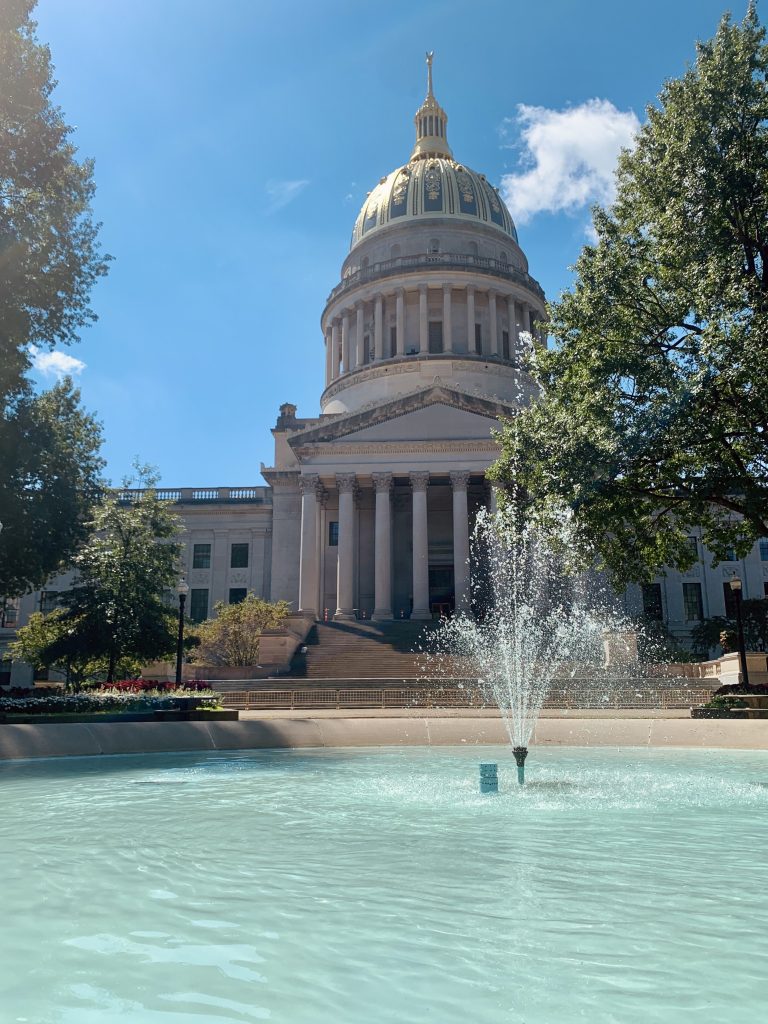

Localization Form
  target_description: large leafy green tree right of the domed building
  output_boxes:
[495,3,768,585]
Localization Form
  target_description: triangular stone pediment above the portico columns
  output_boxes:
[289,384,517,449]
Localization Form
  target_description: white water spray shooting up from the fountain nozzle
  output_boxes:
[427,502,626,784]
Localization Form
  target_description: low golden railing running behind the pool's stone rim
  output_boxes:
[219,683,712,711]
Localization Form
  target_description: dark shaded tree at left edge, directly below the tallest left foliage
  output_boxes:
[0,378,104,597]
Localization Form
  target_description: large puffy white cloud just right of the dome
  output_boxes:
[501,99,640,224]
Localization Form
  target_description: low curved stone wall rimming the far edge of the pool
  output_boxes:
[0,713,768,759]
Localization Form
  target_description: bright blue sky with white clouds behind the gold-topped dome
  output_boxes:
[35,0,746,486]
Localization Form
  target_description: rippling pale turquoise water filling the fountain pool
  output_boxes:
[0,748,768,1024]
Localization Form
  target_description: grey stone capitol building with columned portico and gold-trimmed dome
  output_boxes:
[0,54,768,681]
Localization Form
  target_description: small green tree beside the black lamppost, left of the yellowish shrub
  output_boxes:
[16,479,185,682]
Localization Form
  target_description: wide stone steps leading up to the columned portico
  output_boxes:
[290,620,444,683]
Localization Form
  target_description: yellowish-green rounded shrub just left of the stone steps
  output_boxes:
[195,594,291,668]
